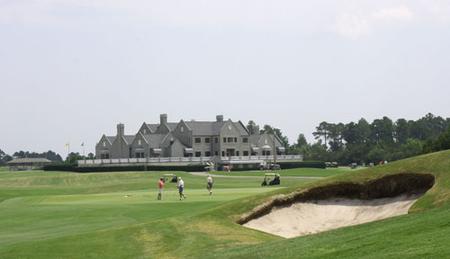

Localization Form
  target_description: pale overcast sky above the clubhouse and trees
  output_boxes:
[0,0,450,155]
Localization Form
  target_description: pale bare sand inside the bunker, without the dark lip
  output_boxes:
[244,195,419,238]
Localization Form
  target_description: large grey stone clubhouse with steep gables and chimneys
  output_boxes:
[95,114,285,159]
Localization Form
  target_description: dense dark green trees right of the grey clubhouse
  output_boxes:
[289,113,450,164]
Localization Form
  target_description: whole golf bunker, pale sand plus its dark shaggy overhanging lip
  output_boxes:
[241,173,435,240]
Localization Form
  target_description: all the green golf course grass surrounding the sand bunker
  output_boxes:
[0,151,450,258]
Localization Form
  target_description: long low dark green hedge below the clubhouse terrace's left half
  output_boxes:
[43,164,205,173]
